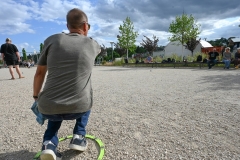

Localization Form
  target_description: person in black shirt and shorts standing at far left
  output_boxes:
[1,38,24,80]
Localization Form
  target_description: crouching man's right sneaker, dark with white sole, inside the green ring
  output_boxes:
[69,134,88,151]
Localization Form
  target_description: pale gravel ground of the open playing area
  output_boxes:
[0,66,240,160]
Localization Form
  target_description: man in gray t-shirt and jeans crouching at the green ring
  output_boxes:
[33,8,101,160]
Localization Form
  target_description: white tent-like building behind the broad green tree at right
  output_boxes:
[153,40,213,57]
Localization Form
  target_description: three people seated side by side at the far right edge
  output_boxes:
[207,47,240,69]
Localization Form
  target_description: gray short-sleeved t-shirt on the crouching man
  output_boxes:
[37,33,101,115]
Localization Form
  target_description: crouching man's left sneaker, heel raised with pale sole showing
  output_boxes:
[40,141,62,160]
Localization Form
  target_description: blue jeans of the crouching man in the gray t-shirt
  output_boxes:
[43,110,91,146]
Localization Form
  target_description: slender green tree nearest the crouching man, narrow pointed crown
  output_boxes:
[117,17,138,58]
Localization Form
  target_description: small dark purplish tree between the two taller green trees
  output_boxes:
[140,35,159,55]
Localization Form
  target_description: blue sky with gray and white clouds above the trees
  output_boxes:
[0,0,240,52]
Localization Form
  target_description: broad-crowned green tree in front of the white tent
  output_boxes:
[169,13,200,58]
